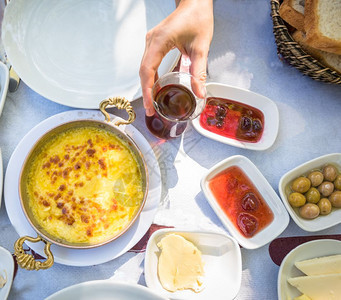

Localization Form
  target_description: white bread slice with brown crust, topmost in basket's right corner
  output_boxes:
[304,0,341,54]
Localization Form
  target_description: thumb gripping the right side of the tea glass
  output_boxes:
[190,53,207,98]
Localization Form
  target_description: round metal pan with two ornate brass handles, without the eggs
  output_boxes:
[14,97,149,270]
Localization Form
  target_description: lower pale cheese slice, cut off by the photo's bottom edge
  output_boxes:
[288,274,341,300]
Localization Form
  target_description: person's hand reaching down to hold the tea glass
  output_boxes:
[140,0,213,116]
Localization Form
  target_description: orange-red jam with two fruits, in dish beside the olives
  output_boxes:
[209,166,274,238]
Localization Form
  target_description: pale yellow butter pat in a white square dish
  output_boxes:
[157,234,204,292]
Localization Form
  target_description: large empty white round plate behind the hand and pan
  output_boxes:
[2,0,179,108]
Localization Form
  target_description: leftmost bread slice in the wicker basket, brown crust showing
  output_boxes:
[279,0,305,32]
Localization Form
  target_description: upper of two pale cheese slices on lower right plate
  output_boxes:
[295,255,341,275]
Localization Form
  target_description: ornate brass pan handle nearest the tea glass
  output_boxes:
[99,97,136,126]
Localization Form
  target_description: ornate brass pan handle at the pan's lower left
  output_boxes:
[14,235,54,271]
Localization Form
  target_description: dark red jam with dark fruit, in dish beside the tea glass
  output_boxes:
[200,97,264,143]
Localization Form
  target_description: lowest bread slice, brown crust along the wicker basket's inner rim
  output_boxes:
[292,30,341,74]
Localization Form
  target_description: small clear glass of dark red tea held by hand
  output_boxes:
[146,72,206,139]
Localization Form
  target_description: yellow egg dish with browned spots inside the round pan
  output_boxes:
[27,126,144,244]
